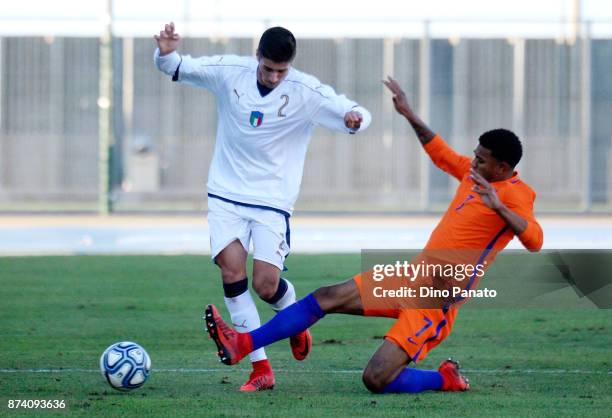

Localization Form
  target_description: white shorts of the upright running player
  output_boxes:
[208,196,290,271]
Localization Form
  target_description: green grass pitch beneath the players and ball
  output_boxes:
[0,254,612,417]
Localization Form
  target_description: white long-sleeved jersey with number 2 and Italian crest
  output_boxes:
[155,49,371,214]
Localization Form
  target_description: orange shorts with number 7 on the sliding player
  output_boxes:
[353,274,457,363]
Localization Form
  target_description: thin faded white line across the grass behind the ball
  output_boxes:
[0,369,612,375]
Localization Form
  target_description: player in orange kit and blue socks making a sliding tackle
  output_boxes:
[204,77,543,393]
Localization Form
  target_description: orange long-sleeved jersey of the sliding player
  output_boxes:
[424,135,543,253]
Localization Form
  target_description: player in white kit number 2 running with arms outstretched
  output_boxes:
[154,23,371,392]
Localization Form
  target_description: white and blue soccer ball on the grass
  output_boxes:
[100,341,151,391]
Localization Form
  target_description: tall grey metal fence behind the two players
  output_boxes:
[0,30,612,212]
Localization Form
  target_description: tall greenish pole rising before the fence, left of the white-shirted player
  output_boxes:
[98,0,113,215]
